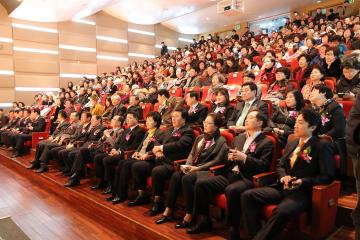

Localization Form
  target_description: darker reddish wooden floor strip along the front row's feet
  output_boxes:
[0,150,224,240]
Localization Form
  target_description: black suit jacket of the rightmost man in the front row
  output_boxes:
[276,137,335,190]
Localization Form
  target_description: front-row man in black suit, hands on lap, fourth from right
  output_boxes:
[129,109,195,216]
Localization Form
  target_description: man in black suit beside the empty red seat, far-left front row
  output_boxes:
[11,108,46,158]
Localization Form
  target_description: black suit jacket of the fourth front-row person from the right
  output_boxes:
[157,125,195,164]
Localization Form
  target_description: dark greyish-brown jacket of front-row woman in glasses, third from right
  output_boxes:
[186,135,228,171]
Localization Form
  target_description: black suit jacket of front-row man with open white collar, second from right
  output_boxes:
[225,133,274,181]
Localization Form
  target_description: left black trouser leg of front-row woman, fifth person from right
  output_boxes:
[112,158,139,199]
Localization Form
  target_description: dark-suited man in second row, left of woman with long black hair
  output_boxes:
[185,91,209,125]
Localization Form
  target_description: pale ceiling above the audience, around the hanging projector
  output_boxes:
[10,0,324,34]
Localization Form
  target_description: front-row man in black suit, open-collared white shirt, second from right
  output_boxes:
[187,110,274,236]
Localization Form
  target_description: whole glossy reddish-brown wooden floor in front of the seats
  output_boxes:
[0,150,354,240]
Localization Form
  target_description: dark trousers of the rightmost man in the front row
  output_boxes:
[241,187,311,240]
